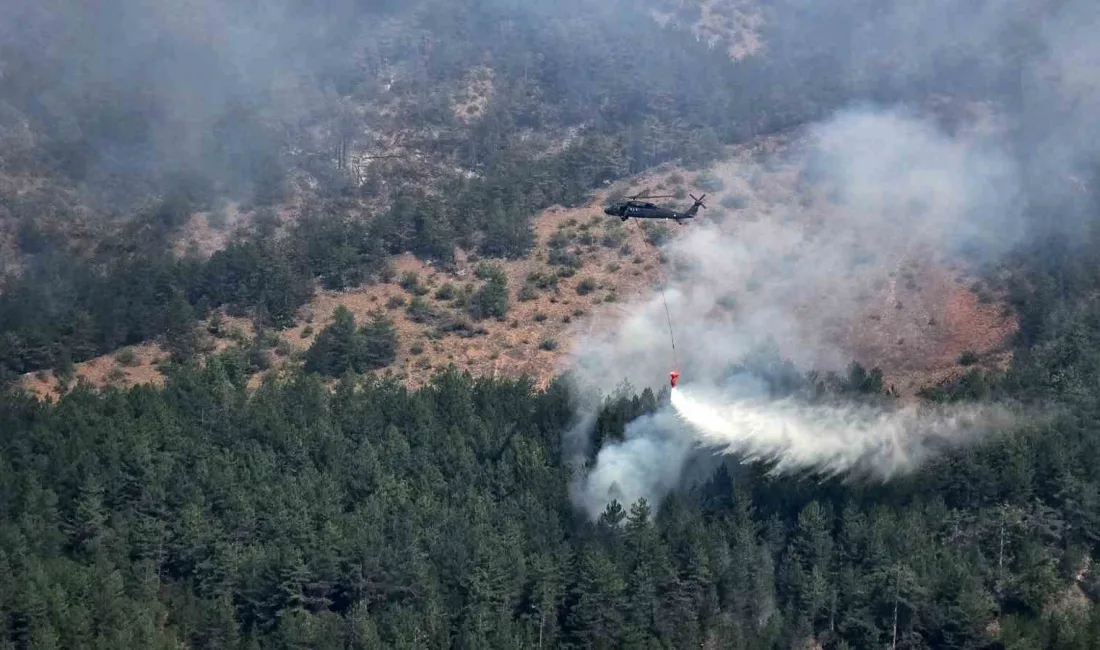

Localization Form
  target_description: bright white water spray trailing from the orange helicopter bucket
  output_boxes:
[671,389,1012,480]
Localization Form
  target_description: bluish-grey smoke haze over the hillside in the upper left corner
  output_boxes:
[0,0,409,205]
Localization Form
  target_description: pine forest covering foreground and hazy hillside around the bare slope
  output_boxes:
[0,0,1100,650]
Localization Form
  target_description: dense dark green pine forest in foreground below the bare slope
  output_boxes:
[0,240,1100,648]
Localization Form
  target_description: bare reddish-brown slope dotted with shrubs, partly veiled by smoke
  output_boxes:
[17,131,1015,402]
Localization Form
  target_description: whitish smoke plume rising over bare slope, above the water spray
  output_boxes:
[571,104,1022,394]
